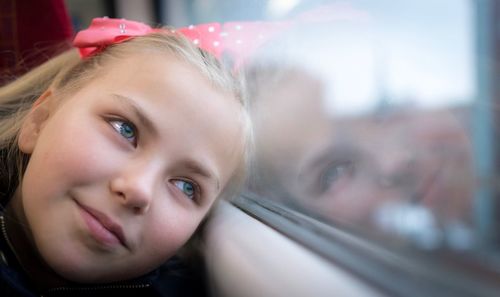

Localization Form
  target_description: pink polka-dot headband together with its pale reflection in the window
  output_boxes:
[73,3,369,68]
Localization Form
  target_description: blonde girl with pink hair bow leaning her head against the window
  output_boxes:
[0,18,250,296]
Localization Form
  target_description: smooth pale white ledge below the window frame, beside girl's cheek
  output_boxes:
[205,202,383,297]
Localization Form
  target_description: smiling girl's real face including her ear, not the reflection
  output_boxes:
[14,53,242,282]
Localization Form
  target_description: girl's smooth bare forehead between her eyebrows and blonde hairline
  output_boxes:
[84,53,243,183]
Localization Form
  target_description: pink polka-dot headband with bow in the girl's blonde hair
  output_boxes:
[73,17,290,67]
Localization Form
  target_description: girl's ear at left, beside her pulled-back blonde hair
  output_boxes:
[17,89,52,154]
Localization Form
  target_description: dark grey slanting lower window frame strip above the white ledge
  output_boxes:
[232,193,500,297]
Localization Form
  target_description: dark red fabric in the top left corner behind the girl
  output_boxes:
[0,0,73,79]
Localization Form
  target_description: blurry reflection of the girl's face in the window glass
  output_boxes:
[255,70,474,224]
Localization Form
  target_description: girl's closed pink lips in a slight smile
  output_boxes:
[76,202,128,248]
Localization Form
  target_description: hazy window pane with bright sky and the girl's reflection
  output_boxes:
[245,0,493,252]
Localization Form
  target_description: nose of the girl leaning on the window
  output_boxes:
[110,160,157,214]
